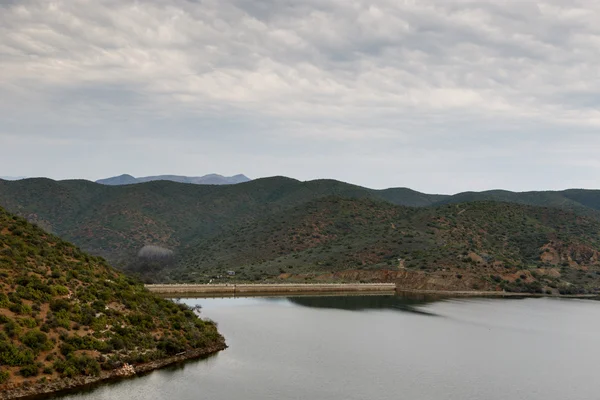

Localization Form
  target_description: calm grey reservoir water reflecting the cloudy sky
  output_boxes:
[50,296,600,400]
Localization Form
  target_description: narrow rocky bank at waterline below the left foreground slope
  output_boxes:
[0,341,227,400]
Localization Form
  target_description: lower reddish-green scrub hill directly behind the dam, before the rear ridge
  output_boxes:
[171,198,600,290]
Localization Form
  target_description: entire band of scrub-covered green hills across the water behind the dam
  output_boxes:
[0,177,600,292]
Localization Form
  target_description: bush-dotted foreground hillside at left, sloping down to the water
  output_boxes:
[0,208,225,398]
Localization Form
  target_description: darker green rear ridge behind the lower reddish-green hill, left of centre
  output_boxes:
[0,177,443,268]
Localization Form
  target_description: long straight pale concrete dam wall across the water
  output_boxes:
[145,283,396,296]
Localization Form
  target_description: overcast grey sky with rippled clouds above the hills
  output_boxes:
[0,0,600,193]
